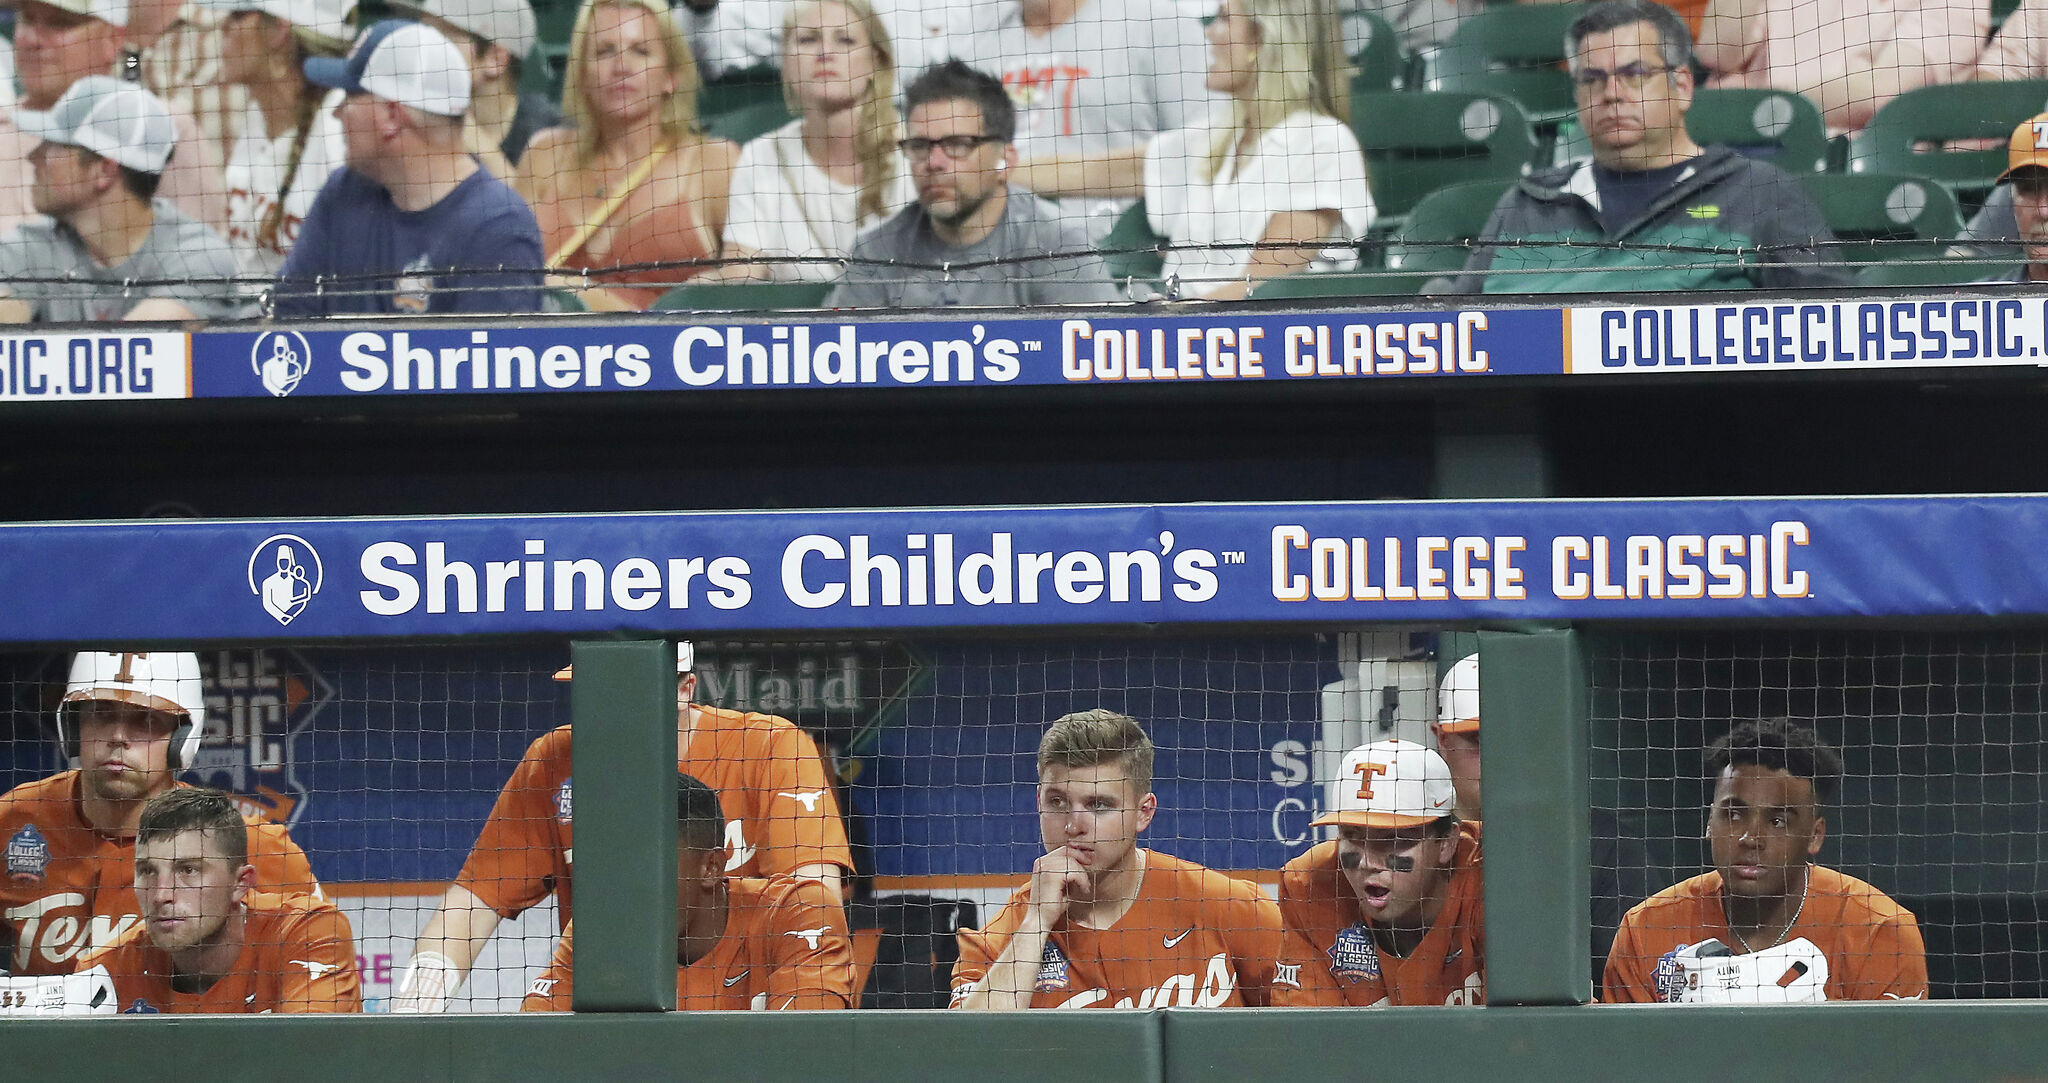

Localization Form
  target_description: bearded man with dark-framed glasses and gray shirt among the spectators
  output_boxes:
[825,59,1118,309]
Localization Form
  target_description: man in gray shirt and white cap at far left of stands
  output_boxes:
[0,76,244,323]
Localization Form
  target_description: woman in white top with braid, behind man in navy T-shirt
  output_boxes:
[211,0,348,278]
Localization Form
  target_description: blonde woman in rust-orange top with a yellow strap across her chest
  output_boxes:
[514,0,739,311]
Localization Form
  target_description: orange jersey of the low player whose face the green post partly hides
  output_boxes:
[520,876,854,1011]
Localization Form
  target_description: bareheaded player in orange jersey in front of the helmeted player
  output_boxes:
[82,788,362,1015]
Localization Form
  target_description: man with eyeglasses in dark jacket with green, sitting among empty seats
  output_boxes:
[1423,0,1849,293]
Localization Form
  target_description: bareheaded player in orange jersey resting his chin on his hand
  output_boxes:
[952,710,1309,1009]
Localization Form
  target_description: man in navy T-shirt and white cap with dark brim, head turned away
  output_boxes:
[274,18,545,317]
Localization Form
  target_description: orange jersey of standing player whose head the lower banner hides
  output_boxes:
[455,706,854,929]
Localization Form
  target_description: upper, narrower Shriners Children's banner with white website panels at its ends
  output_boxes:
[0,291,2048,401]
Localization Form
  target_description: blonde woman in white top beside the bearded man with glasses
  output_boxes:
[721,0,915,280]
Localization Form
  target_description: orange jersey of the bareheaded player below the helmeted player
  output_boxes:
[80,891,362,1015]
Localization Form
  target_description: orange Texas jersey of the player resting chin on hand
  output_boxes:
[952,850,1307,1007]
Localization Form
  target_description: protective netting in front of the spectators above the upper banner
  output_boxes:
[0,0,2048,321]
